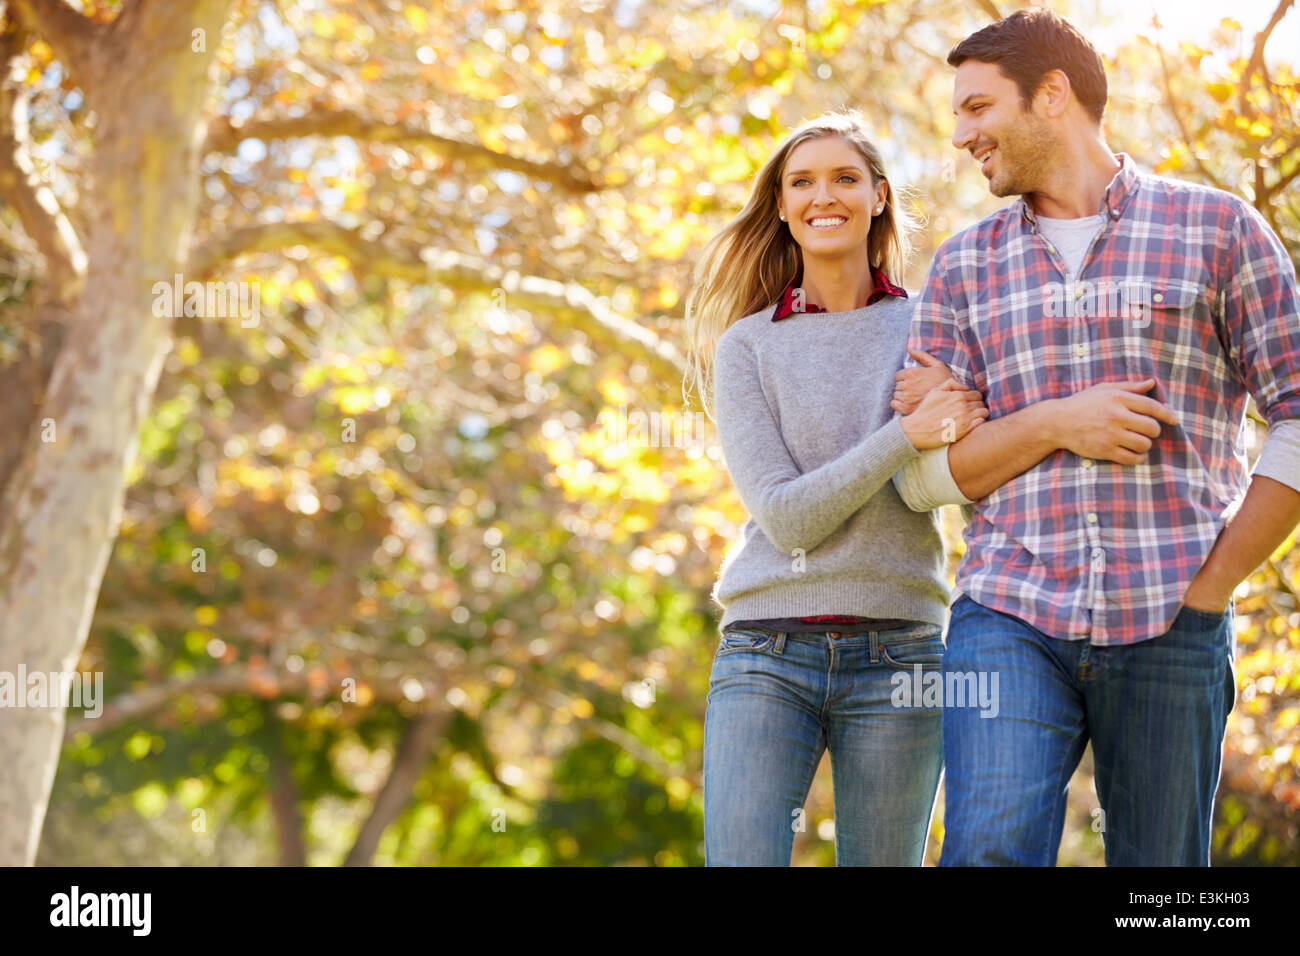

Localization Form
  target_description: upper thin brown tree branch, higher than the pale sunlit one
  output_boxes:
[203,107,601,193]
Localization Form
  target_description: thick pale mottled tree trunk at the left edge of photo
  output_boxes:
[0,0,233,865]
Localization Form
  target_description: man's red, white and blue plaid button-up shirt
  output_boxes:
[905,153,1300,645]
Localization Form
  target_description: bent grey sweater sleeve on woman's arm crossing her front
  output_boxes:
[714,327,918,554]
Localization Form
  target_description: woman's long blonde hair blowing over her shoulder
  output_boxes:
[683,109,917,420]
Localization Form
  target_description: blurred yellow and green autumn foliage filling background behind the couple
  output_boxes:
[0,0,1300,865]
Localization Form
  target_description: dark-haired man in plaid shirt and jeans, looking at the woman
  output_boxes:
[894,9,1300,866]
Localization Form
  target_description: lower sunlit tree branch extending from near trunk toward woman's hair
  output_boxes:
[186,221,686,376]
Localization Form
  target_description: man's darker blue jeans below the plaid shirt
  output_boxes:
[940,594,1236,866]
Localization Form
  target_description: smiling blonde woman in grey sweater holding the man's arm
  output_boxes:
[686,111,988,866]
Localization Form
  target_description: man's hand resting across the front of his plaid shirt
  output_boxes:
[1049,378,1178,464]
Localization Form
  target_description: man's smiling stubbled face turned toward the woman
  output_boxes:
[953,60,1054,196]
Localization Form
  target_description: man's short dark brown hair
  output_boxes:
[948,8,1106,125]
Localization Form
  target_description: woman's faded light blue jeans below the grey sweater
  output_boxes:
[705,623,944,866]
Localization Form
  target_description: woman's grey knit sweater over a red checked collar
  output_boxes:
[712,298,949,630]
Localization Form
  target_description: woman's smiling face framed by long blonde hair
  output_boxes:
[776,137,889,258]
